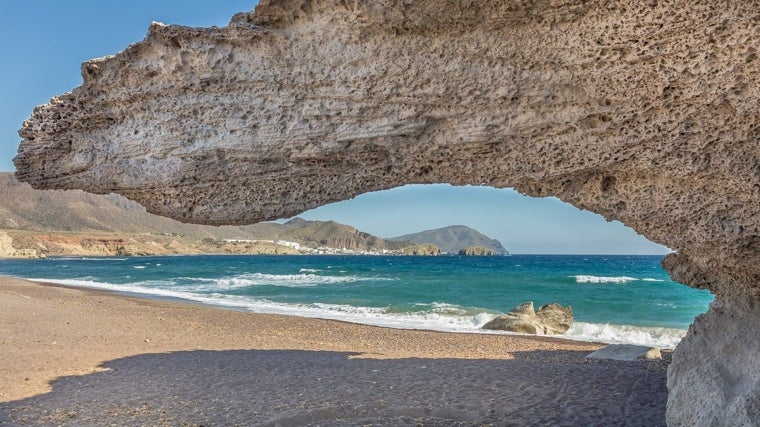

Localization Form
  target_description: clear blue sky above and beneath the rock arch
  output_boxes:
[0,0,668,254]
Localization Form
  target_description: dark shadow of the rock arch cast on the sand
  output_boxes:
[0,350,667,426]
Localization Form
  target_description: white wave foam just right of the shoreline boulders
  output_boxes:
[563,322,686,348]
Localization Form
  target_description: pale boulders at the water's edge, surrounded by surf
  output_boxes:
[482,301,573,335]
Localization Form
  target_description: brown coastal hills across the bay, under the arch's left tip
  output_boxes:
[0,173,409,256]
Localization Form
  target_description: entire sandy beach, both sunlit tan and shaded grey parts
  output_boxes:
[0,278,667,426]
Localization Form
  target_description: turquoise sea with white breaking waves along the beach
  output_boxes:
[0,255,712,348]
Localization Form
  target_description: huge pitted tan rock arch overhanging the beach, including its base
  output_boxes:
[10,0,760,425]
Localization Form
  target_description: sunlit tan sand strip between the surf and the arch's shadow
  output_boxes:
[0,277,604,402]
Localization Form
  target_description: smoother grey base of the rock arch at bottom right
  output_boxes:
[668,298,760,426]
